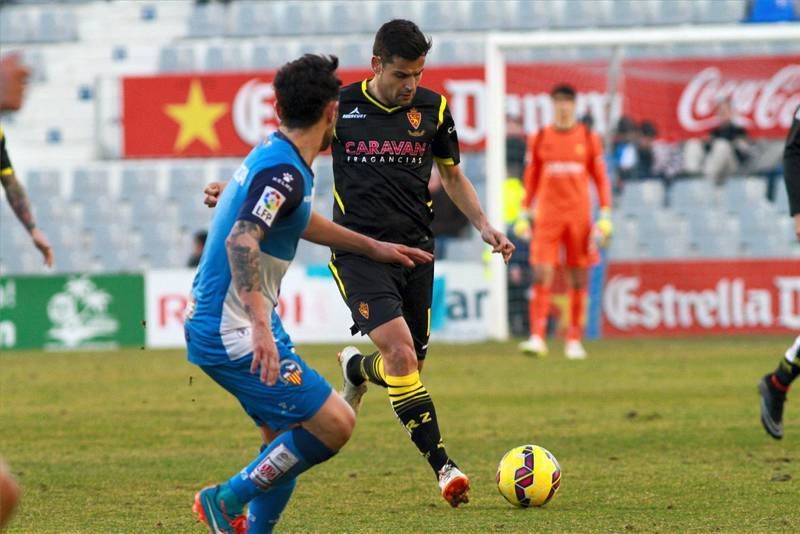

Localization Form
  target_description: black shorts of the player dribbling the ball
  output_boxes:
[328,254,433,360]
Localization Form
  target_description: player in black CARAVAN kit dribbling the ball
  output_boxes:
[329,20,514,506]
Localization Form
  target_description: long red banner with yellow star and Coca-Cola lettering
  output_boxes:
[122,55,800,158]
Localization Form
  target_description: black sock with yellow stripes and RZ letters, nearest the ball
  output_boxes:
[386,371,449,473]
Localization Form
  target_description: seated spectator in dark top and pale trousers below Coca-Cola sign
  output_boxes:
[683,100,751,186]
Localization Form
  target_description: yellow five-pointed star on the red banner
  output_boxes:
[164,80,228,152]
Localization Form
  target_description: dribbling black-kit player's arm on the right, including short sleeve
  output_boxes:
[433,97,514,263]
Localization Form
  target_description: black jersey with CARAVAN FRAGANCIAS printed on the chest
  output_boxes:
[332,80,460,246]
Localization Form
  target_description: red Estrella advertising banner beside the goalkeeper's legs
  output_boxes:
[603,260,800,337]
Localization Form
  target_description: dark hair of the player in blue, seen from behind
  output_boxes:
[272,54,342,128]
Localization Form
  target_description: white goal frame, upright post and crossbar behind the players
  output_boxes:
[484,23,800,340]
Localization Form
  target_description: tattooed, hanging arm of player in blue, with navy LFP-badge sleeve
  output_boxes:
[225,165,303,386]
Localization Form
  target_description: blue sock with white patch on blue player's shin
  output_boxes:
[228,427,336,504]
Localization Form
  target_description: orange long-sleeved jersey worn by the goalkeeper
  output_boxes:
[523,124,611,221]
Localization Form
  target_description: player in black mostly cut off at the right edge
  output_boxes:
[758,103,800,439]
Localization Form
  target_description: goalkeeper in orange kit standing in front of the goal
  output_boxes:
[520,84,612,359]
